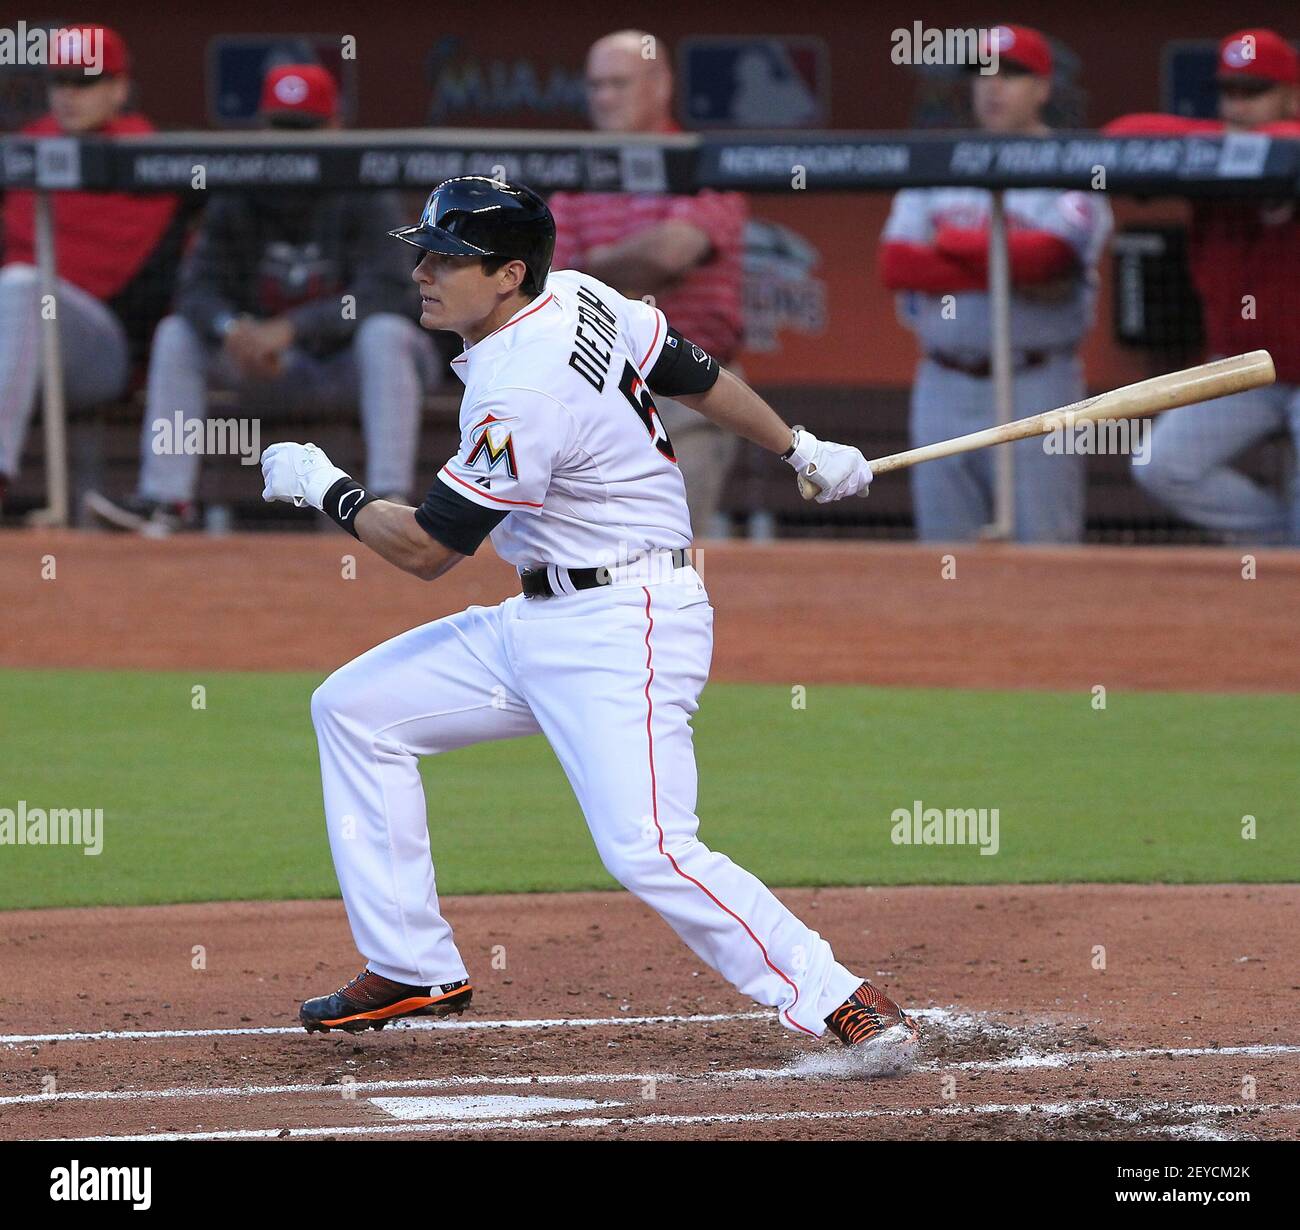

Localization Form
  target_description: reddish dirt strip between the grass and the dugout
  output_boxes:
[0,527,1300,692]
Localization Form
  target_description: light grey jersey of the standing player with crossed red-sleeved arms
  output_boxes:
[883,187,1113,359]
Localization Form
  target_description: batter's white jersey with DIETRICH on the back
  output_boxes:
[438,269,690,567]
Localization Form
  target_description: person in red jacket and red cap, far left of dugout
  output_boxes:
[0,25,185,512]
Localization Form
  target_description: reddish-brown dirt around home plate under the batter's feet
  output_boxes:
[0,885,1300,1139]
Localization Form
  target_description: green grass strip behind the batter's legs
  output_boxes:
[0,671,1300,909]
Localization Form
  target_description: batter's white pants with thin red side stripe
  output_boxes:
[312,564,862,1035]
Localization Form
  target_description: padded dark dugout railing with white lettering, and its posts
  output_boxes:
[0,130,1300,541]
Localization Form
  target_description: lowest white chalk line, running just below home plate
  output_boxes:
[47,1097,1300,1143]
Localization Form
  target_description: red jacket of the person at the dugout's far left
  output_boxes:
[4,114,179,300]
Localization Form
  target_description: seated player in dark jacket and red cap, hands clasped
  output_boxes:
[86,64,445,536]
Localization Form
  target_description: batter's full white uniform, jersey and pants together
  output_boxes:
[312,272,862,1036]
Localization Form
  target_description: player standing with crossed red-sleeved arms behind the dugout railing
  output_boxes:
[880,26,1112,542]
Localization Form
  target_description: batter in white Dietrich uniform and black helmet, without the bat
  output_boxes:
[263,177,917,1070]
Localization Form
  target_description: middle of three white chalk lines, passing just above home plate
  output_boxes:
[0,1045,1300,1106]
